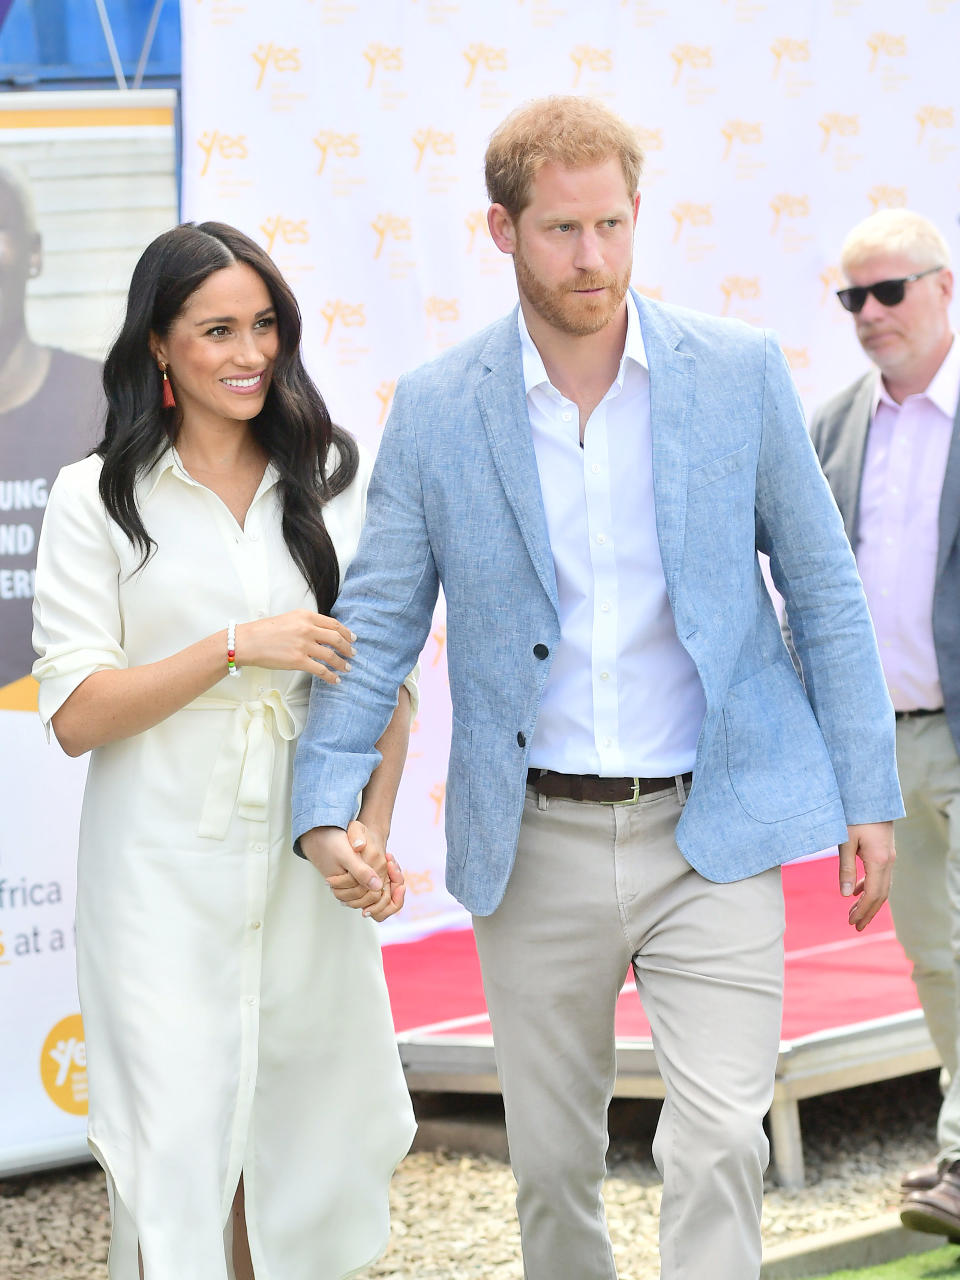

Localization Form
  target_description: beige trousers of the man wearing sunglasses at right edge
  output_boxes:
[890,716,960,1161]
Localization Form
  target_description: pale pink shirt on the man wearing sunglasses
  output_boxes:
[856,338,960,710]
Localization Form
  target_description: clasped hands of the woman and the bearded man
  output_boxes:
[300,819,407,920]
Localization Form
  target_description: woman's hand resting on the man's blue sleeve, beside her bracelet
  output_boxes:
[236,609,356,685]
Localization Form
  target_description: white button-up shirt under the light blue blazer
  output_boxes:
[520,294,705,777]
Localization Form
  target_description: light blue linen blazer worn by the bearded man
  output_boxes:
[293,296,902,915]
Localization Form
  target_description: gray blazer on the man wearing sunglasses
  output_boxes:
[810,370,960,750]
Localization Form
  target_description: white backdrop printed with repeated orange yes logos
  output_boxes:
[182,0,960,940]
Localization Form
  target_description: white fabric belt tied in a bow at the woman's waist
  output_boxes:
[188,689,310,840]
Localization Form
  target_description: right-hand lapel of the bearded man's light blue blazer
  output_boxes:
[634,293,696,599]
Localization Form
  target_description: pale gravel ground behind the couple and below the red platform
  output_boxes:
[0,1073,940,1280]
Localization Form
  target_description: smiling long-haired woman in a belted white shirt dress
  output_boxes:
[35,223,415,1280]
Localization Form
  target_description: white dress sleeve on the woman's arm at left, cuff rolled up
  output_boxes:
[33,458,127,735]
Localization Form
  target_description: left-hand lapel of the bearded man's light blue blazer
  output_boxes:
[476,308,559,612]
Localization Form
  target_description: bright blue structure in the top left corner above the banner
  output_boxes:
[0,0,180,92]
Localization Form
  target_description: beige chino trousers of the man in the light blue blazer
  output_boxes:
[474,788,783,1280]
